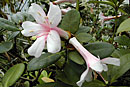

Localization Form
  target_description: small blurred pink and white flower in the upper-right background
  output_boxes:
[99,12,121,28]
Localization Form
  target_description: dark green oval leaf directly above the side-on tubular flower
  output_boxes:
[85,42,115,58]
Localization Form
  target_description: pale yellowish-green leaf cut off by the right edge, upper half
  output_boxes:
[116,18,130,34]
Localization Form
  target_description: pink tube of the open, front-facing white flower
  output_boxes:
[53,27,71,39]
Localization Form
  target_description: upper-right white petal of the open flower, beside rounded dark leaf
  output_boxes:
[47,3,61,27]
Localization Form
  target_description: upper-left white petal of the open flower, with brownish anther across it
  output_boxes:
[29,3,46,24]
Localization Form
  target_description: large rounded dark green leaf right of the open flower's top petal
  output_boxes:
[60,10,80,34]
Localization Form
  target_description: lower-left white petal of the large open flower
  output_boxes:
[28,36,46,58]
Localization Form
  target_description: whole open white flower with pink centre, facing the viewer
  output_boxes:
[22,3,69,57]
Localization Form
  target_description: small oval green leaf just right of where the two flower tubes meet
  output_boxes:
[75,33,92,43]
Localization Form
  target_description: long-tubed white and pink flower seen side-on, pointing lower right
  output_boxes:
[69,37,120,87]
